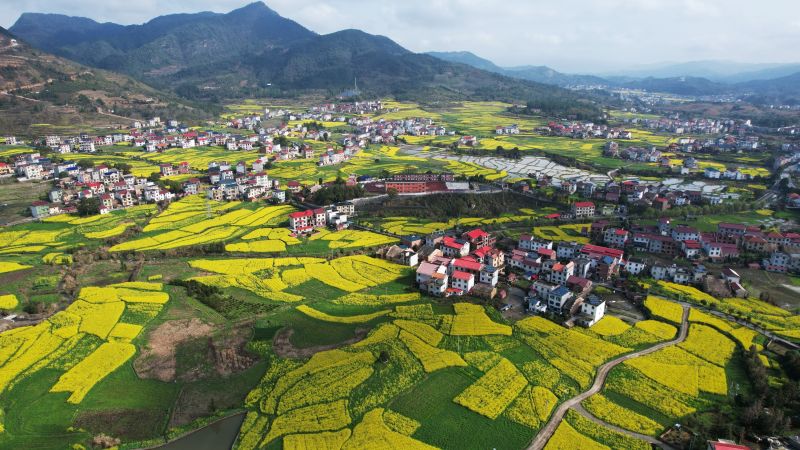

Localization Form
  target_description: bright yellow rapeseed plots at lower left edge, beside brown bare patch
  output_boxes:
[0,283,169,412]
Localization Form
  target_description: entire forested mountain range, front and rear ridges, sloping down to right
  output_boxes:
[11,2,600,118]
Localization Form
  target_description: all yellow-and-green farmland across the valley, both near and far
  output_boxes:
[0,100,800,450]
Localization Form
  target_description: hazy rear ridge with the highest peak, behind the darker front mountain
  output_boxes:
[10,2,316,79]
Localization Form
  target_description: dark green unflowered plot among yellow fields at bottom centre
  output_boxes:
[390,368,533,449]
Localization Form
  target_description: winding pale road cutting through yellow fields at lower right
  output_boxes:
[528,305,689,450]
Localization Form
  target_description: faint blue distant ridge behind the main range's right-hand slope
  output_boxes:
[427,51,608,87]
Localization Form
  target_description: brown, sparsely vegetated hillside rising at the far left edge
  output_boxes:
[0,28,213,134]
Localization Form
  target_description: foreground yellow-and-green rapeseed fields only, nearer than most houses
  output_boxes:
[0,193,768,449]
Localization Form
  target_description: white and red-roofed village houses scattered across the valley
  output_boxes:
[6,101,800,314]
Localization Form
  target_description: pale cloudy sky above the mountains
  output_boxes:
[0,0,800,72]
